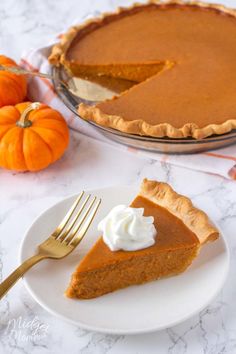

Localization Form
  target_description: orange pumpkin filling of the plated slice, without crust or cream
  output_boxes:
[66,196,200,299]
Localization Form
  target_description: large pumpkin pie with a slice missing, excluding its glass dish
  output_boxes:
[49,1,236,139]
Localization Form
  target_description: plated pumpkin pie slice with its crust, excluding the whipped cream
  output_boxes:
[66,179,219,299]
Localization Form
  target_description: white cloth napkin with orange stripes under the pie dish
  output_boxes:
[20,44,236,180]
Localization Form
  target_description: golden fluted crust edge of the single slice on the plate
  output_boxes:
[139,179,219,244]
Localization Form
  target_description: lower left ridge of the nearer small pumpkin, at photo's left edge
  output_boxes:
[0,127,26,171]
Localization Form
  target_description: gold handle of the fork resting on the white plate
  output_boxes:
[0,254,48,299]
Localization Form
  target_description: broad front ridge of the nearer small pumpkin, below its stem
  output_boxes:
[23,129,53,171]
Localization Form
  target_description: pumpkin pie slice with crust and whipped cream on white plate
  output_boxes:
[66,179,219,299]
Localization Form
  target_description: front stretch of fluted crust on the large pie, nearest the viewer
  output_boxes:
[78,103,236,139]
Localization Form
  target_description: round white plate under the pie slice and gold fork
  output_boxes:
[20,187,229,334]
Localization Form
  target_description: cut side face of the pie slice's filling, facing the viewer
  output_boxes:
[66,247,198,299]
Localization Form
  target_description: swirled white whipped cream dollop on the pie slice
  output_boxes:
[98,205,157,251]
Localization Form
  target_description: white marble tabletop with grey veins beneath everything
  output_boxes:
[0,0,236,354]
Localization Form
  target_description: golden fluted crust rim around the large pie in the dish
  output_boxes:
[49,0,236,139]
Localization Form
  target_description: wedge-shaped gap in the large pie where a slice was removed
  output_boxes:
[67,61,174,102]
